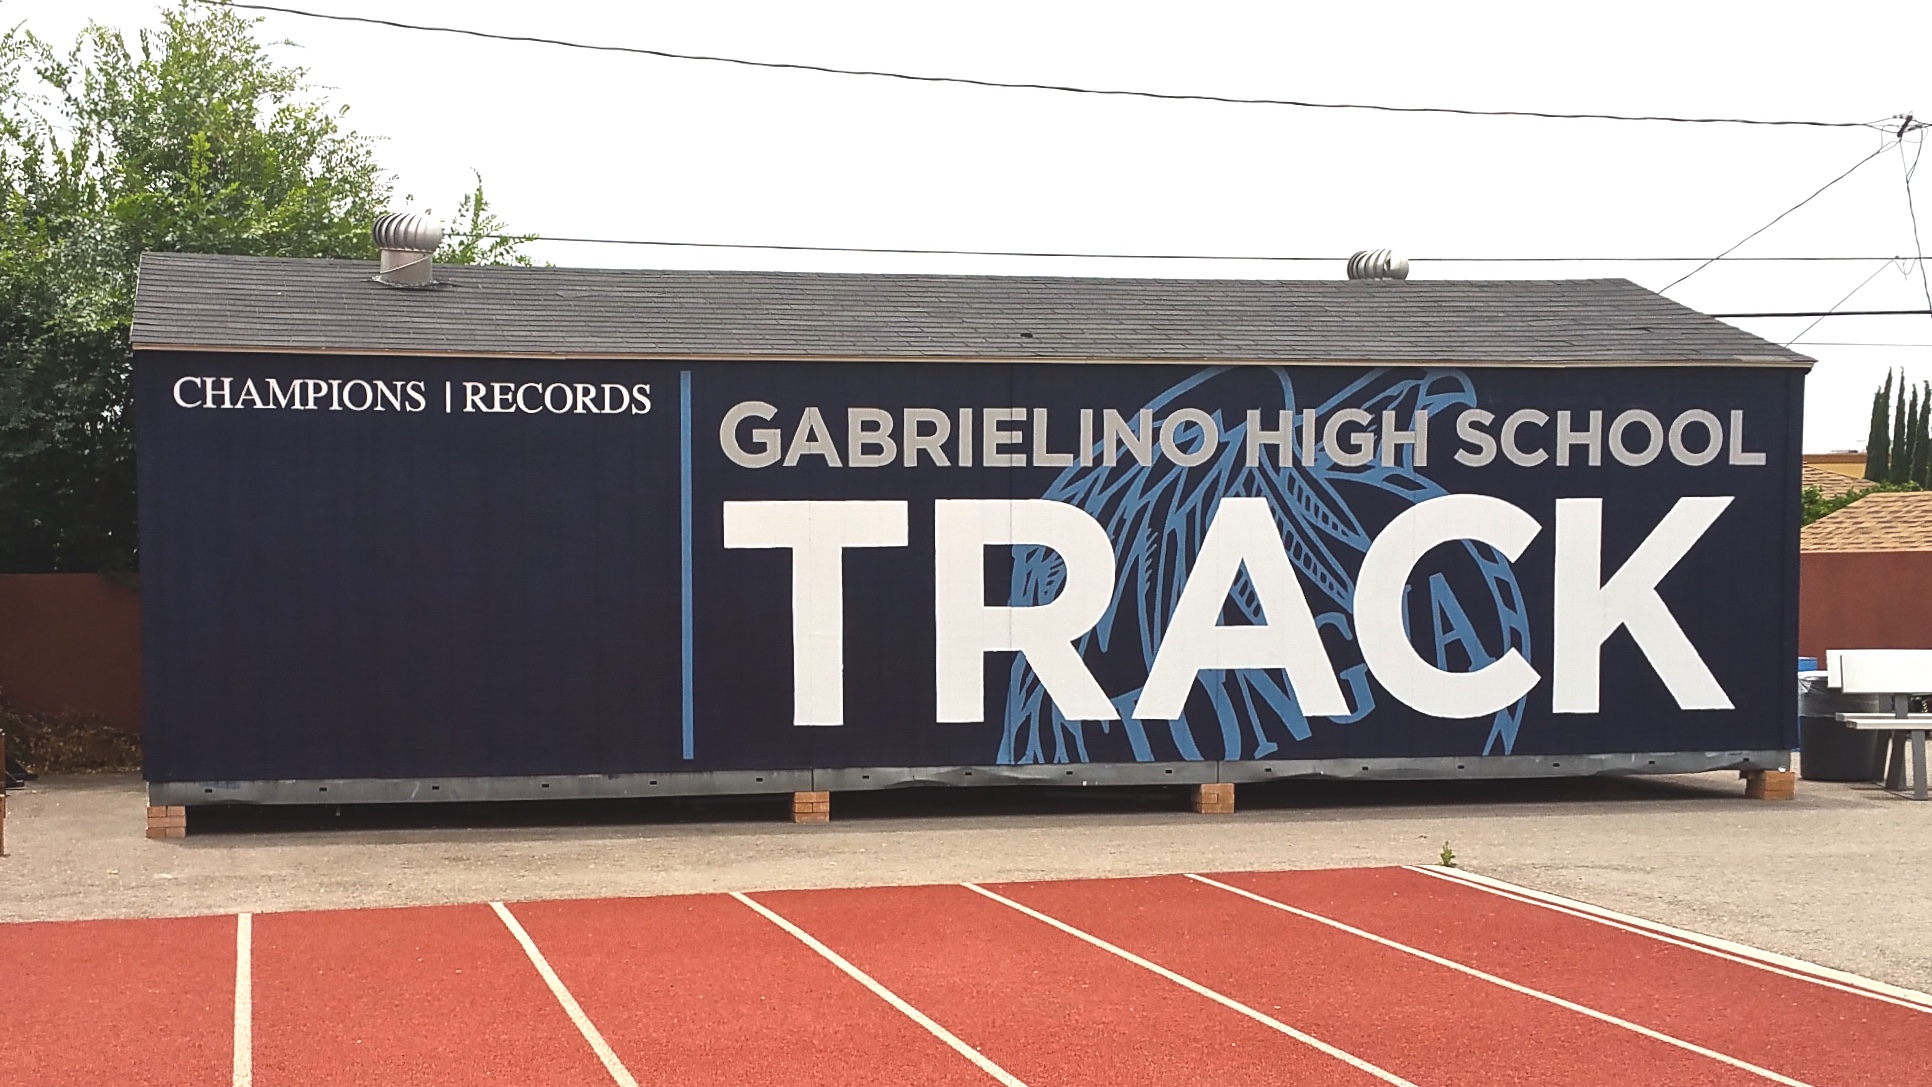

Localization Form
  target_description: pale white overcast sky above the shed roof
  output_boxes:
[0,0,1932,452]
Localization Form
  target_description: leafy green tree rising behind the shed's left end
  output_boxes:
[0,0,522,570]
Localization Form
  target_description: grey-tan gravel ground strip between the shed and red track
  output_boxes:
[0,774,1932,990]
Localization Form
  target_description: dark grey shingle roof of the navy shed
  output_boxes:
[133,253,1810,365]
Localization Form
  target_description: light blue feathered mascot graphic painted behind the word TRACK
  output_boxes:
[997,367,1530,765]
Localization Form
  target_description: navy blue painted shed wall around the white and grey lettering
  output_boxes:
[135,353,1803,782]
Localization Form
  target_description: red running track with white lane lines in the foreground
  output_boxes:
[0,869,1932,1087]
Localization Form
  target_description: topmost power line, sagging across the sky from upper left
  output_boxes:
[197,0,1893,131]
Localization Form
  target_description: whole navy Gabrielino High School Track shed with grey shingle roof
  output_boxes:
[133,255,1810,805]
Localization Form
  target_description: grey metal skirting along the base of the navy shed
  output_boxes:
[147,751,1791,805]
